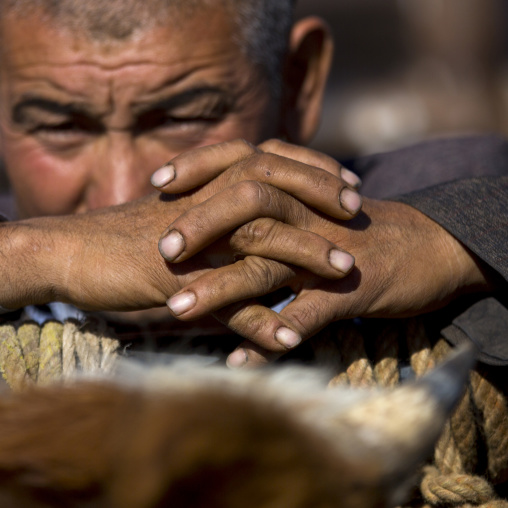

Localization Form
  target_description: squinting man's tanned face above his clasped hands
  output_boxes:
[0,10,278,218]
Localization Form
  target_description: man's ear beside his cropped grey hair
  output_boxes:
[282,17,333,144]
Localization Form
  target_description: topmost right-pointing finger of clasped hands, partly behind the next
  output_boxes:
[259,139,362,189]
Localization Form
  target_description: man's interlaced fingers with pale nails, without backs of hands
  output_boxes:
[152,140,362,366]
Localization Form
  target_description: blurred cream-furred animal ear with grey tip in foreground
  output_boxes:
[324,346,475,506]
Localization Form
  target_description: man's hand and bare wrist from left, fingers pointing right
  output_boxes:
[0,142,361,318]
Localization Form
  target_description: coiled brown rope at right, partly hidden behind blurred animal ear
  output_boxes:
[330,317,508,508]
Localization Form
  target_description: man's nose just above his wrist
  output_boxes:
[83,132,158,211]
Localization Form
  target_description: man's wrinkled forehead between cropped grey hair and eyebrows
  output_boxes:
[0,8,248,89]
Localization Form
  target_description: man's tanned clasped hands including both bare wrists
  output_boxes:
[11,141,491,366]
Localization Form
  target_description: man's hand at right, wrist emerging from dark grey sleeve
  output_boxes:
[164,199,490,365]
